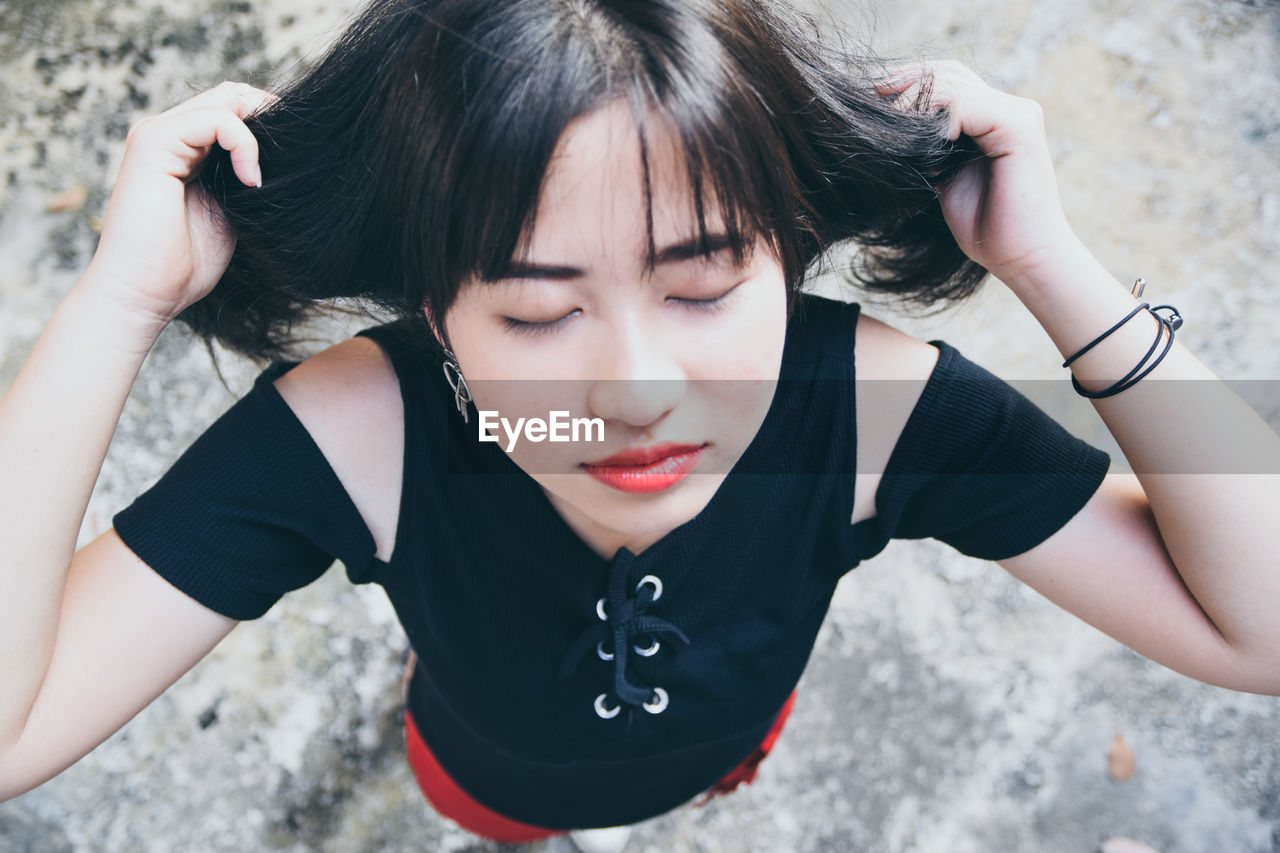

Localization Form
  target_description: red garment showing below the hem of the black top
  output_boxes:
[404,692,796,844]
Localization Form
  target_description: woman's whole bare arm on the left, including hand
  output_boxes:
[0,83,270,798]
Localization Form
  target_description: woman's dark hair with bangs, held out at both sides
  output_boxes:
[178,0,986,360]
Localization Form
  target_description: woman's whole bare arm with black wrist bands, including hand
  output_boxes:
[884,63,1280,694]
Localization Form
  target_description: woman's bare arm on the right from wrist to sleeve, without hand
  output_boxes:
[1002,256,1280,695]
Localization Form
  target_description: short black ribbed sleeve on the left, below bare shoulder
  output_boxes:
[113,361,375,620]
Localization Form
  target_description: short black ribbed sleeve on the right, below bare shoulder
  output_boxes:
[861,341,1111,560]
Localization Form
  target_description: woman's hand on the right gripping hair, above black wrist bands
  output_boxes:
[878,60,1082,289]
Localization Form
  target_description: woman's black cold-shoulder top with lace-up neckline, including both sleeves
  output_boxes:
[114,296,1110,829]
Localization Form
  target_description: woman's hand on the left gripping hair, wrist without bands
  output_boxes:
[88,82,279,323]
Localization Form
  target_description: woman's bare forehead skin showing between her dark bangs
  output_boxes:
[526,100,719,264]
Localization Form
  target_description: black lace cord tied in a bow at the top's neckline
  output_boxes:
[559,552,690,708]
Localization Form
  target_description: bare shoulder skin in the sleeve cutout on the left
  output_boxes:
[275,337,404,560]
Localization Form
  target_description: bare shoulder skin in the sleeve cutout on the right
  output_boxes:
[850,313,941,524]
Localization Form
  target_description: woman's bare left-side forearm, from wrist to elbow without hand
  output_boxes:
[0,274,168,748]
